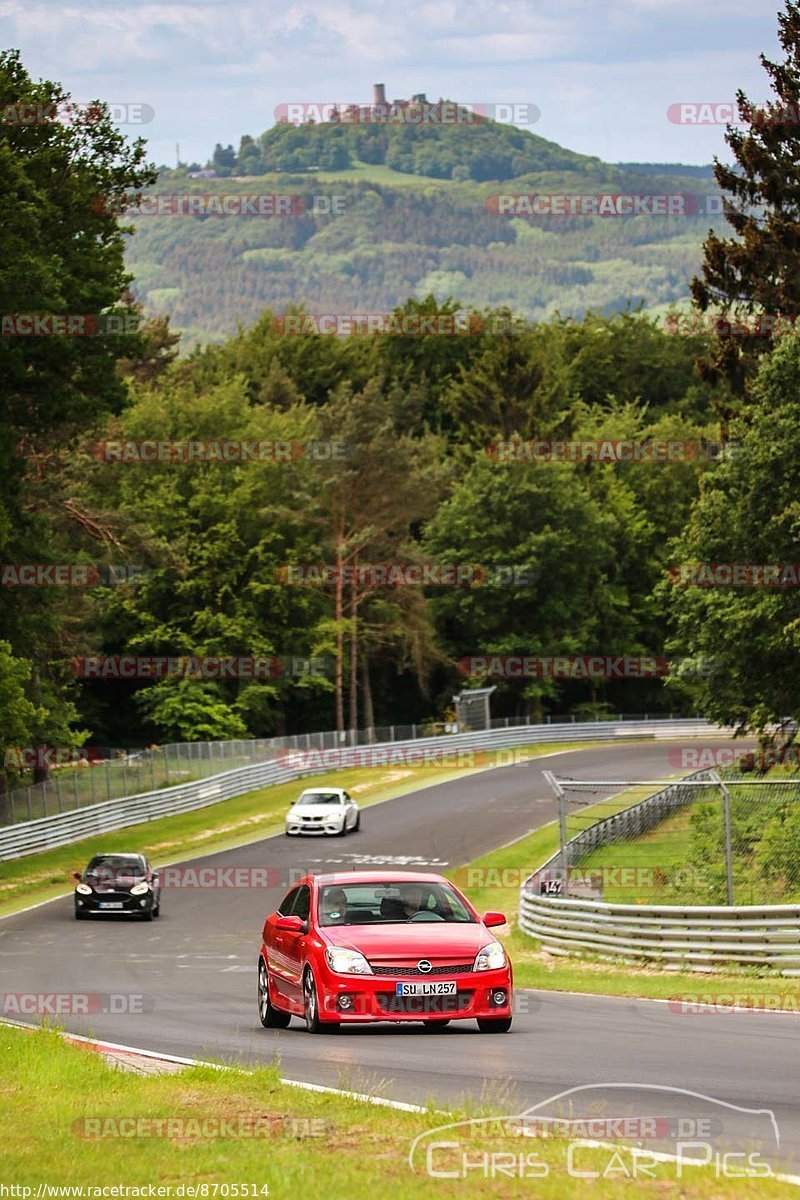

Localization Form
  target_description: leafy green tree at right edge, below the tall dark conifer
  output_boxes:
[662,337,800,727]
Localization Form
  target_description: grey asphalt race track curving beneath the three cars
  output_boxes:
[0,742,800,1171]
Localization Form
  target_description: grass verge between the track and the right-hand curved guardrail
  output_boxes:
[447,788,800,1010]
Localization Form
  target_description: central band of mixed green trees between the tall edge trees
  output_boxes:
[0,299,717,744]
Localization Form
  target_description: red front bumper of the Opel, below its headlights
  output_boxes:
[317,966,513,1022]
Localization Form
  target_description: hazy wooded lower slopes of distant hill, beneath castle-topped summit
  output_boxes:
[127,166,727,346]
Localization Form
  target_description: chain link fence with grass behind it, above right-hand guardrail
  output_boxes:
[536,767,800,906]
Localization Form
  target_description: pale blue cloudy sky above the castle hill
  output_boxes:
[0,0,780,164]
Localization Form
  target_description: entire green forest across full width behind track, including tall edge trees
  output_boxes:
[0,23,800,801]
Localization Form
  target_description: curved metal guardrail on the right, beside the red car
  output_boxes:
[519,772,800,976]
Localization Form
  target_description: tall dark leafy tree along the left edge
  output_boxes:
[0,53,155,791]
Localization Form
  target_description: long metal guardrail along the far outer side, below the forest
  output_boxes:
[0,718,727,860]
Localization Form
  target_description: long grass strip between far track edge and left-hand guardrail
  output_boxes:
[0,743,594,913]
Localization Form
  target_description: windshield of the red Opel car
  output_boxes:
[319,881,476,926]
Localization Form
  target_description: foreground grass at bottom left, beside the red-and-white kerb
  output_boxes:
[0,1026,786,1200]
